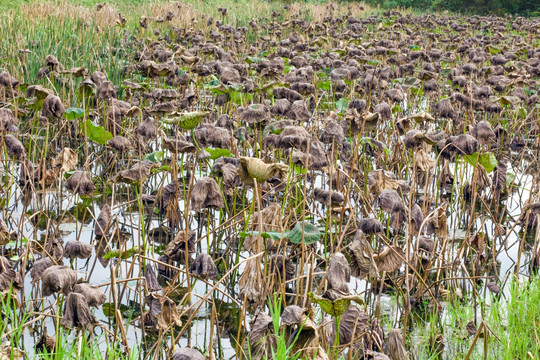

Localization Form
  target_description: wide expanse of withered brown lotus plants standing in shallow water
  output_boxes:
[0,3,540,360]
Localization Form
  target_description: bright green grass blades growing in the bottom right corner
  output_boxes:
[411,276,540,360]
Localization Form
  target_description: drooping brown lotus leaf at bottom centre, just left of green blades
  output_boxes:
[248,312,277,360]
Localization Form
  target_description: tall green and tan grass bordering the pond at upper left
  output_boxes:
[0,0,380,87]
